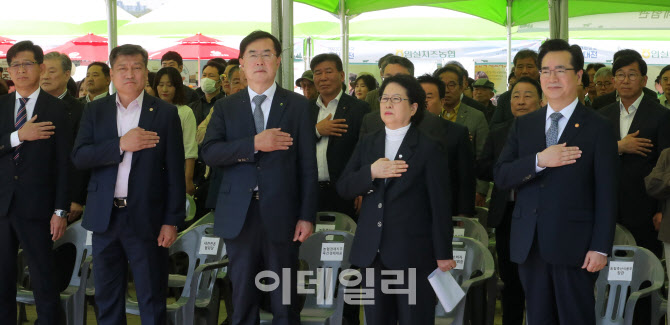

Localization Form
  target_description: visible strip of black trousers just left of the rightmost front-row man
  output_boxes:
[496,202,526,325]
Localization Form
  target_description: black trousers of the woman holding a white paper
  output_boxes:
[361,254,437,325]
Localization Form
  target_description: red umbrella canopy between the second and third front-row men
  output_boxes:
[149,33,240,60]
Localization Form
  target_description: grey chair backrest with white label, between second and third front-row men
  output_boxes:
[170,224,226,298]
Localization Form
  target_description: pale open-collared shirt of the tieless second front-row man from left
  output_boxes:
[114,91,144,198]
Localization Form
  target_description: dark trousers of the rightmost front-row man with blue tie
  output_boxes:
[519,235,598,325]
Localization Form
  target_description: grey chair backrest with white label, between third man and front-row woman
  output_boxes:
[298,230,354,310]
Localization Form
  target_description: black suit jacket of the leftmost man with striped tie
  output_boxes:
[0,90,72,220]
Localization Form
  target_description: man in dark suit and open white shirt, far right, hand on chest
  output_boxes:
[600,55,670,257]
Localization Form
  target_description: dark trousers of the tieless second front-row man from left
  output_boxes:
[93,208,168,325]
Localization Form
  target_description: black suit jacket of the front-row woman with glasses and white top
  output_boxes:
[337,126,453,269]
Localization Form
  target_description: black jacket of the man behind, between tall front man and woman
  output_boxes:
[310,93,370,182]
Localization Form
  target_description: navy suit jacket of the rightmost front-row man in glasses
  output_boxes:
[494,103,618,267]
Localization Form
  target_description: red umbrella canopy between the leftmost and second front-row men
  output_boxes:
[47,33,109,62]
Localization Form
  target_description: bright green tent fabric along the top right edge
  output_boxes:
[296,0,670,26]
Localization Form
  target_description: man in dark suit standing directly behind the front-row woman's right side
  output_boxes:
[418,74,475,216]
